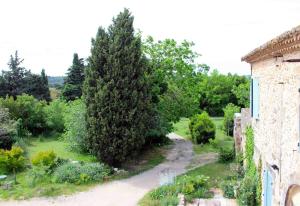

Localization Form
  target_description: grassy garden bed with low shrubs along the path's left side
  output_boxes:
[0,135,168,199]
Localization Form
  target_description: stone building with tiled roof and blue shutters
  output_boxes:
[242,26,300,206]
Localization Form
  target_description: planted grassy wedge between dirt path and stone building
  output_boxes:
[139,163,235,206]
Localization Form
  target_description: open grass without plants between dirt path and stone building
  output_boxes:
[139,163,234,206]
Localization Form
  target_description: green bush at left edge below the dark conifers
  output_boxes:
[0,94,46,134]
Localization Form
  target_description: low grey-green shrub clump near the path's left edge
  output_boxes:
[54,163,110,184]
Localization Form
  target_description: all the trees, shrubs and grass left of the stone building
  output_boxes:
[0,9,251,201]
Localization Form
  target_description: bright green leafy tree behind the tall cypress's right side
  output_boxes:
[143,37,204,122]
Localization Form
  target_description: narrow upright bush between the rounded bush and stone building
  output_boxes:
[223,103,241,136]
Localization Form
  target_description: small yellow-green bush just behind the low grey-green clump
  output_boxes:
[31,151,56,168]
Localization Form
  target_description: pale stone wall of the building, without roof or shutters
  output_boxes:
[251,52,300,206]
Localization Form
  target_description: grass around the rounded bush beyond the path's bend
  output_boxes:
[173,117,234,154]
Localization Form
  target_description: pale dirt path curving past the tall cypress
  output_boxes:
[0,133,193,206]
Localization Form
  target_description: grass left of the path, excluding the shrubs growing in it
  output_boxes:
[0,134,171,199]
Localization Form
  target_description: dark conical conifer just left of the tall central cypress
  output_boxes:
[62,53,84,101]
